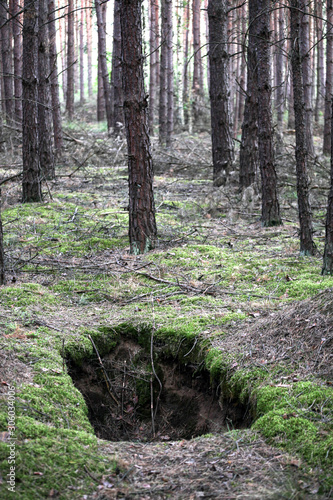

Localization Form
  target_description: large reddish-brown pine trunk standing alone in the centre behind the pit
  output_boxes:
[120,0,157,254]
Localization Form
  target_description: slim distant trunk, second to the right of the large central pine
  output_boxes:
[159,0,168,144]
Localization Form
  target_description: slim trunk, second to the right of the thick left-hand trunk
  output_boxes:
[48,0,62,157]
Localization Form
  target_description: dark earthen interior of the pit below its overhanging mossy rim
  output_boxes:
[68,338,250,441]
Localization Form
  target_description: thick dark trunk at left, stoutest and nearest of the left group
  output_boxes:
[22,0,42,203]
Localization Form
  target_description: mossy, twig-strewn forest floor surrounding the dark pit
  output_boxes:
[0,119,333,500]
